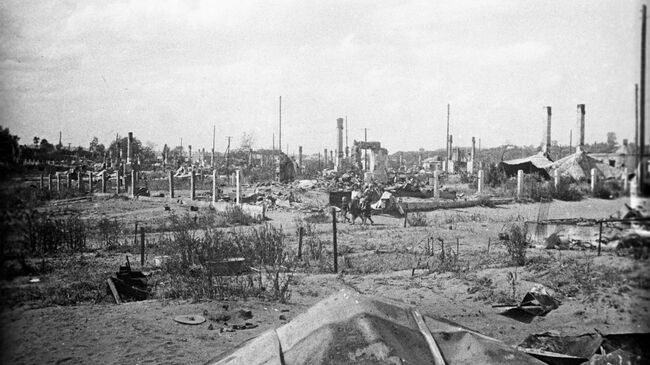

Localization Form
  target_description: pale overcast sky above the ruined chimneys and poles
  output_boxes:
[0,0,642,153]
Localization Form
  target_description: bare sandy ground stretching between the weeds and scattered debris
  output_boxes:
[0,198,650,364]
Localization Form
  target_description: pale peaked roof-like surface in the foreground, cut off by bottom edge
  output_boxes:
[209,290,544,364]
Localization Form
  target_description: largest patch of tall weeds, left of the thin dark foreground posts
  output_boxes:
[159,216,294,301]
